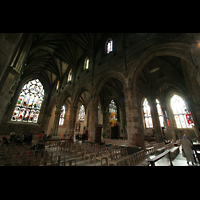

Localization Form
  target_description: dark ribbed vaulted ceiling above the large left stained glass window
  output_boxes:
[23,33,106,83]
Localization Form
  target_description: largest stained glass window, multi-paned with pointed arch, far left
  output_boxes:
[11,79,44,123]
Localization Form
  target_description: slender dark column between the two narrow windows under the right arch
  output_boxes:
[148,97,164,143]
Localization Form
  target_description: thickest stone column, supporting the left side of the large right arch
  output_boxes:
[124,87,145,149]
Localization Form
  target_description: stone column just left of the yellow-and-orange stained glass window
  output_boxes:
[88,99,98,142]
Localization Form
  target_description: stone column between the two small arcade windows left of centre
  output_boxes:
[67,106,77,138]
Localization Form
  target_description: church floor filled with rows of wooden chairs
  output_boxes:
[0,140,199,166]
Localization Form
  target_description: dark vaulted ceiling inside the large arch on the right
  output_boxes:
[137,56,187,96]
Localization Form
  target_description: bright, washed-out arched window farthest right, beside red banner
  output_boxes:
[171,95,192,128]
